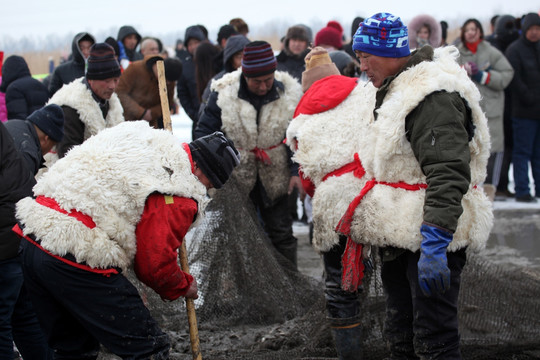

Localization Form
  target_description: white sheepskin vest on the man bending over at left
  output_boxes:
[16,121,208,269]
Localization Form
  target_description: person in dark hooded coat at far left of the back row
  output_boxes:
[0,55,49,120]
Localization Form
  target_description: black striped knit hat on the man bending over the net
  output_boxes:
[189,131,240,189]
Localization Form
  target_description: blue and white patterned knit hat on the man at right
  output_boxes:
[353,13,411,58]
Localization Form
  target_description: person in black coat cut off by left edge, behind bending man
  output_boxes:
[0,122,53,360]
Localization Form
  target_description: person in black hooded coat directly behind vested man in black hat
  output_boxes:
[48,32,96,96]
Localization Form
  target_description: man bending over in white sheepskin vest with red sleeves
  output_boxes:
[13,121,240,359]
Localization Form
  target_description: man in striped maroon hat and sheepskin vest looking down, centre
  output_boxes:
[195,41,303,267]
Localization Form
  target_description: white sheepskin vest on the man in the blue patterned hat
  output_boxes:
[351,46,493,251]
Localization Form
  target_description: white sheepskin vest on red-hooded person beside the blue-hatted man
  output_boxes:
[287,75,376,252]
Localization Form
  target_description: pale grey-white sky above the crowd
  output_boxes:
[0,0,540,44]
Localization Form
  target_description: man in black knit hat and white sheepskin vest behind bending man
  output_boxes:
[48,43,124,162]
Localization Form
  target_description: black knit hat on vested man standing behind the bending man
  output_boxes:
[86,43,121,80]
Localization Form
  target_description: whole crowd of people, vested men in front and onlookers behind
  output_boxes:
[0,13,540,360]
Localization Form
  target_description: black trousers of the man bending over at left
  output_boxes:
[21,240,170,360]
